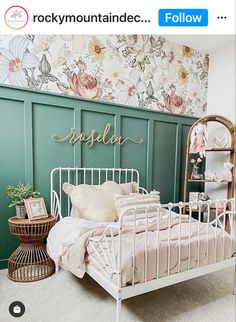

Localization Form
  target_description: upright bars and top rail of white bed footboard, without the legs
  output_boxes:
[89,199,235,289]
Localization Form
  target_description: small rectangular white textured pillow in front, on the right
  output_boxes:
[115,191,160,221]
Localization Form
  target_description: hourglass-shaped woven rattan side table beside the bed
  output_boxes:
[8,216,56,282]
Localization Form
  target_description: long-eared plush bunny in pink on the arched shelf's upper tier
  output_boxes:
[189,123,208,158]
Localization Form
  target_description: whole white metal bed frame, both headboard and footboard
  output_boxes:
[50,168,236,322]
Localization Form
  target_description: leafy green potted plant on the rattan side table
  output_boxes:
[6,183,40,219]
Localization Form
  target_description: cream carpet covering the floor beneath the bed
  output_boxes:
[0,268,235,322]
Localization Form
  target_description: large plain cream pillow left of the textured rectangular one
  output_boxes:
[63,181,122,221]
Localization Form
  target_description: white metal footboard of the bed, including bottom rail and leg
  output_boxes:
[88,199,235,322]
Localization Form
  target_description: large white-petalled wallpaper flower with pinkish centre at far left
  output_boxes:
[0,36,39,86]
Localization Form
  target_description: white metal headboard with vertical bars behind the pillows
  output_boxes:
[50,167,140,218]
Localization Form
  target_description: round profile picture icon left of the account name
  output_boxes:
[4,6,29,30]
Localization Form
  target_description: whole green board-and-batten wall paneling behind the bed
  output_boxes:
[0,85,196,268]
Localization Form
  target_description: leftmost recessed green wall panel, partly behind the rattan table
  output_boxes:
[0,98,26,267]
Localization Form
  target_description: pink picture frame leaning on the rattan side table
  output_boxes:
[24,198,48,220]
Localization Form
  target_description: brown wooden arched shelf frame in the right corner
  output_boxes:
[184,115,236,231]
